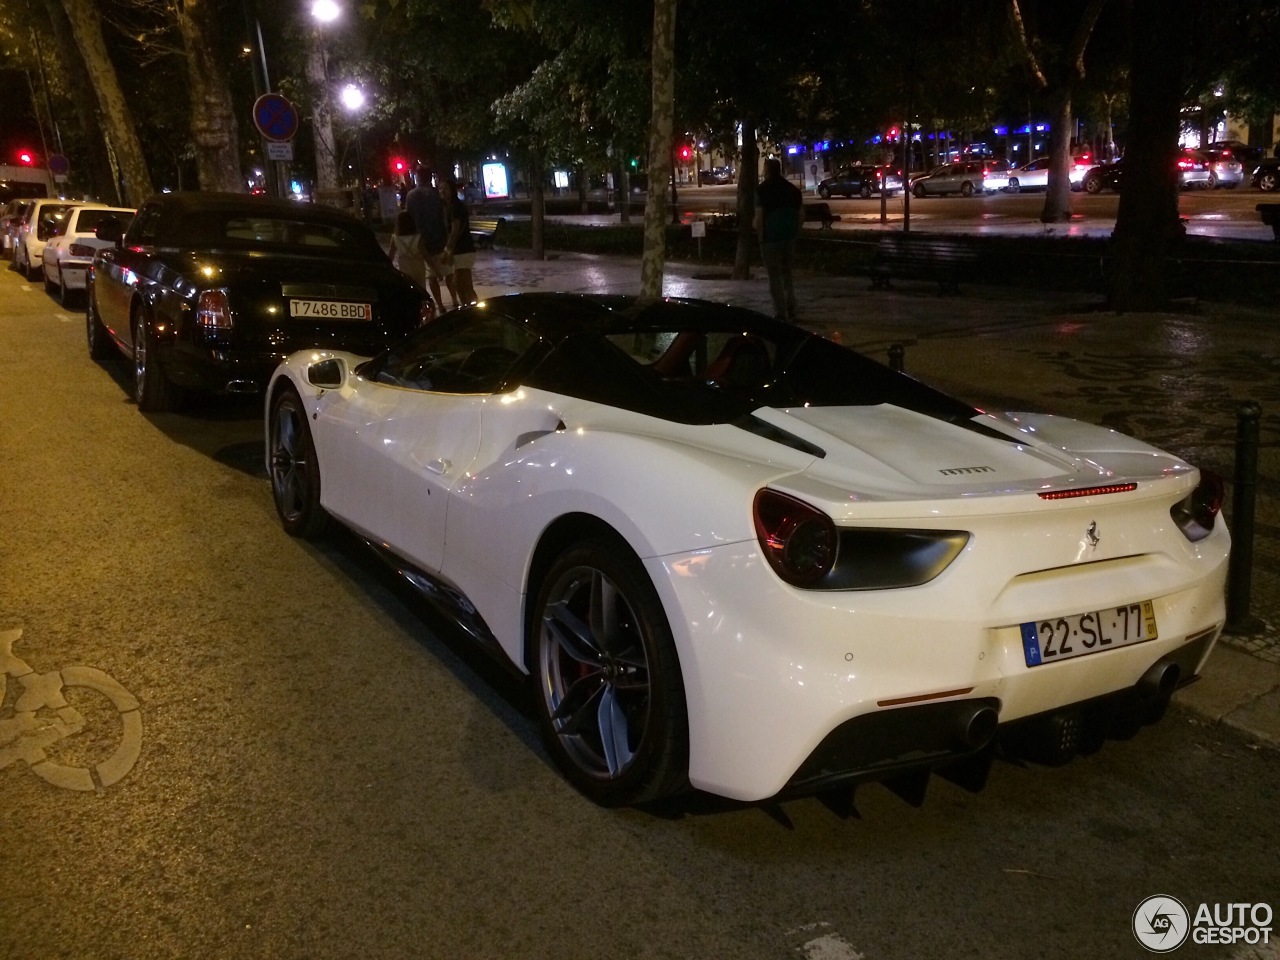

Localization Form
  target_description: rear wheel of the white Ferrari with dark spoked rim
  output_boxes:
[529,538,689,806]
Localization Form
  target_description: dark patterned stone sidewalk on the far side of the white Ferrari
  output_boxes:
[475,241,1280,745]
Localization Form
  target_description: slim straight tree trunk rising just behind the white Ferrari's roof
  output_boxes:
[640,0,676,298]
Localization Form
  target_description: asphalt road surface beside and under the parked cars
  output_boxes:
[0,263,1280,960]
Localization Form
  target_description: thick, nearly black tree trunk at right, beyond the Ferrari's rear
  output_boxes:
[1107,0,1193,311]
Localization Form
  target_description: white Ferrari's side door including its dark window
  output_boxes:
[314,307,531,572]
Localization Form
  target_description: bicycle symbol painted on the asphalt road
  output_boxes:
[0,628,142,791]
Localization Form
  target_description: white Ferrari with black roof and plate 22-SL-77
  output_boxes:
[265,293,1229,804]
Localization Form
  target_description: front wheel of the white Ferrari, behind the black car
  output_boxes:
[266,385,329,540]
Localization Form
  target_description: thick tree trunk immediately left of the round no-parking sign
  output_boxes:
[178,0,246,193]
